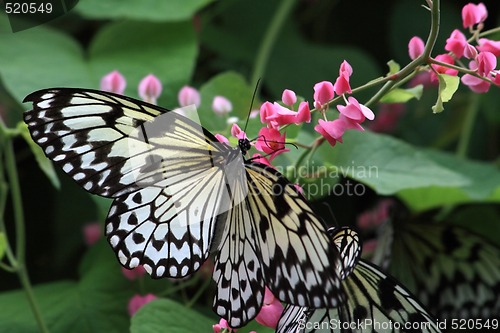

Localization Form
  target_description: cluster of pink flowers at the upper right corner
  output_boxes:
[408,3,500,93]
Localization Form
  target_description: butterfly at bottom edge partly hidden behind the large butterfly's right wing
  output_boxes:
[276,227,440,333]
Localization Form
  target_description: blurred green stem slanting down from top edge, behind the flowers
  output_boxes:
[250,0,296,89]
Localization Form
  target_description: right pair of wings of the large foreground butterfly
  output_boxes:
[214,163,344,327]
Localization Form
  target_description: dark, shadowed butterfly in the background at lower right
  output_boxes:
[366,202,500,322]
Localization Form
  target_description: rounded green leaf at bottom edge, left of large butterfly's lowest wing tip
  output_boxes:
[130,299,216,333]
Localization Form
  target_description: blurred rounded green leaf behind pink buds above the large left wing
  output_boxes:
[89,21,197,108]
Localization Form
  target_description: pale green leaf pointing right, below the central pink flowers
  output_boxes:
[318,131,469,195]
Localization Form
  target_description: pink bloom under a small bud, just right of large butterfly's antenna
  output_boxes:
[261,102,311,128]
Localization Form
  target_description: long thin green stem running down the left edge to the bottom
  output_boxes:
[0,124,49,333]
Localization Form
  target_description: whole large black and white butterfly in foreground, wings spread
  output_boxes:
[24,88,354,328]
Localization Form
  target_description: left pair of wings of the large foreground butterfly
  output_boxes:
[24,89,243,277]
